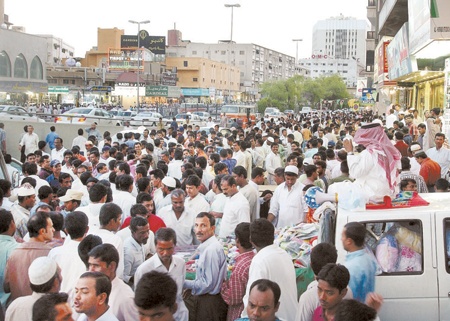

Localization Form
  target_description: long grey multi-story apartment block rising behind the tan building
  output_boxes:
[166,30,296,101]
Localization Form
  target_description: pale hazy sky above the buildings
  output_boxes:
[4,0,367,58]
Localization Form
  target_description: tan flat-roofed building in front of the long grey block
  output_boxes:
[166,57,240,102]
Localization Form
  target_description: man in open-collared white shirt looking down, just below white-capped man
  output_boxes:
[158,189,196,246]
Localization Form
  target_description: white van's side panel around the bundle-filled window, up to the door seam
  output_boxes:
[337,209,438,321]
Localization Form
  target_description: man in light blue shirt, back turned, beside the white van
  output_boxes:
[342,222,377,303]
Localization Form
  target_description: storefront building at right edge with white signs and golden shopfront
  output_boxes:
[367,0,450,115]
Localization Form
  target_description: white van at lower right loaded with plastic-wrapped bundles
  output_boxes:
[334,193,450,321]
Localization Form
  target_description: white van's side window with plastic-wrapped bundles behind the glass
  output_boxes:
[363,220,423,275]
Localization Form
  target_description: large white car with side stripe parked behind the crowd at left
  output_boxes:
[55,107,115,125]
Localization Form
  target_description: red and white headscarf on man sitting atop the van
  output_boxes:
[354,123,402,191]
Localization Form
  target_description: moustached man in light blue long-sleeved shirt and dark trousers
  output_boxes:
[183,212,228,321]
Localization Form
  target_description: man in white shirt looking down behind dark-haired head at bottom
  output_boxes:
[134,227,188,321]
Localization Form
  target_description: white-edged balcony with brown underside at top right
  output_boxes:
[378,0,408,37]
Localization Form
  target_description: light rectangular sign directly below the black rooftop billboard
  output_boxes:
[108,48,144,71]
